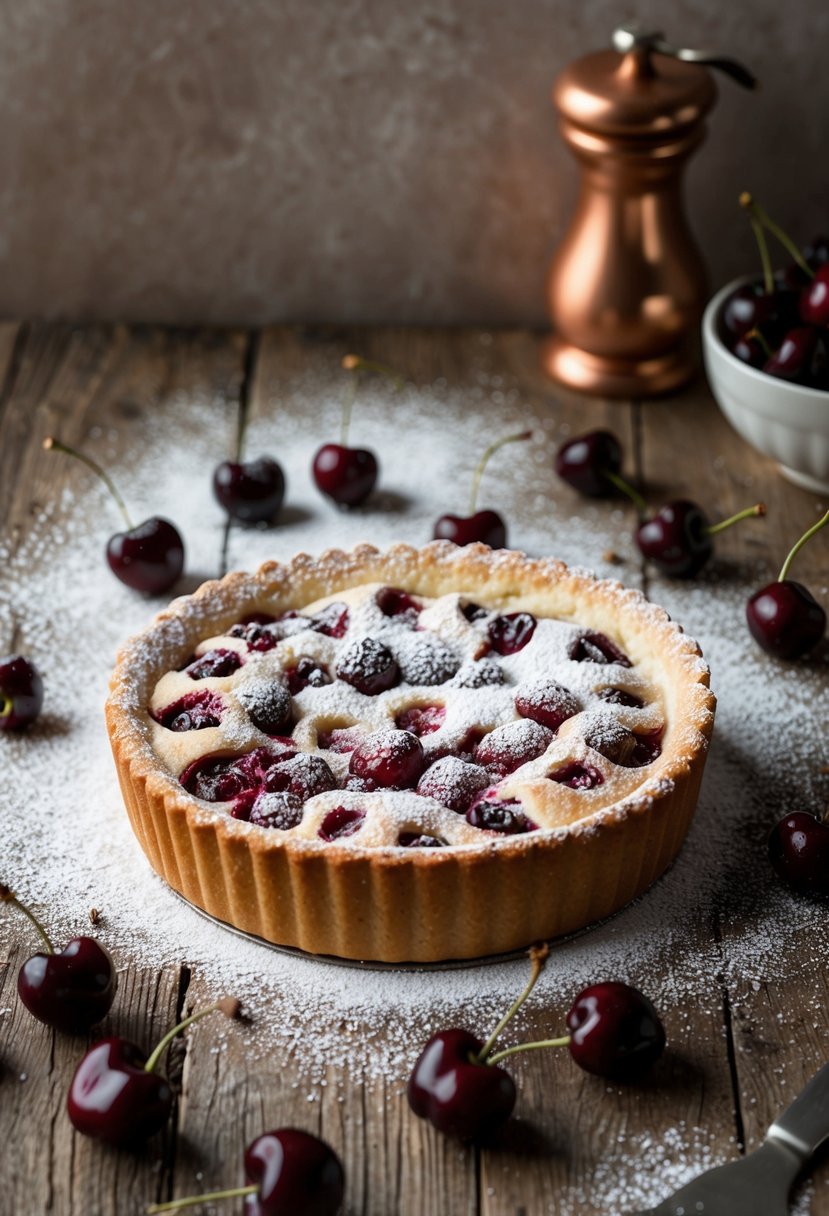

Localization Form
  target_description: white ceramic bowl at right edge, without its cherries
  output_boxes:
[703,278,829,494]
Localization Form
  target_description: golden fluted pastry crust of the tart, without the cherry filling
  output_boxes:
[107,542,715,962]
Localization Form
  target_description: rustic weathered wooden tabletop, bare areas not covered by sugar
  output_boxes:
[0,325,829,1216]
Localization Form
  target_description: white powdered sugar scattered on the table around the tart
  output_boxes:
[0,362,829,1214]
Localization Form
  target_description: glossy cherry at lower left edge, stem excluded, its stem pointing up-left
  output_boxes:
[17,938,118,1035]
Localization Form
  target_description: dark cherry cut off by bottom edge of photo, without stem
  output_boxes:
[244,1127,345,1216]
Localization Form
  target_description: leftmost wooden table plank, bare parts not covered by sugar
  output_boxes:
[0,325,244,1216]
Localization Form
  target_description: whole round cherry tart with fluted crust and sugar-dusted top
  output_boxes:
[108,542,712,961]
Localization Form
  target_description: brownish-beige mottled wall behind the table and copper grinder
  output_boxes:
[0,0,829,323]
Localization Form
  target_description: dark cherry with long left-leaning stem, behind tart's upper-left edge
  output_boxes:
[44,435,185,595]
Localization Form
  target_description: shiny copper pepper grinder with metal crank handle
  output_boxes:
[543,26,755,399]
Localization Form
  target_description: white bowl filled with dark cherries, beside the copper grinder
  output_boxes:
[703,195,829,494]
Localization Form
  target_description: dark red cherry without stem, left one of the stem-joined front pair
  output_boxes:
[407,1030,515,1141]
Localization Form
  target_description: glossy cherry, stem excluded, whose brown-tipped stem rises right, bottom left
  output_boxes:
[67,1037,173,1148]
